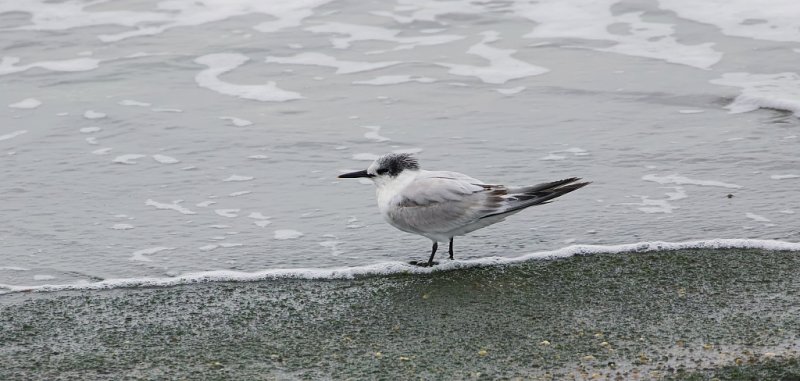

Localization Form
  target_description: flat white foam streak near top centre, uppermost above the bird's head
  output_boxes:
[306,22,464,51]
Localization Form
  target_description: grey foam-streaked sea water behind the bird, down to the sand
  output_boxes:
[0,0,800,293]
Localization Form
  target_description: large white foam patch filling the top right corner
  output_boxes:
[658,0,800,42]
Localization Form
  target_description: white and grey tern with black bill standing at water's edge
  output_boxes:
[339,153,590,267]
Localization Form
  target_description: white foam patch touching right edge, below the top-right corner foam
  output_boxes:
[710,73,800,117]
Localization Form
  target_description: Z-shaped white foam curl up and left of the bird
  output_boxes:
[194,53,303,102]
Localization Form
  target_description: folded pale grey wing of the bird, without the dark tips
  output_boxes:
[386,176,507,237]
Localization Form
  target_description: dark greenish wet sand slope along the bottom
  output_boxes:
[0,249,800,380]
